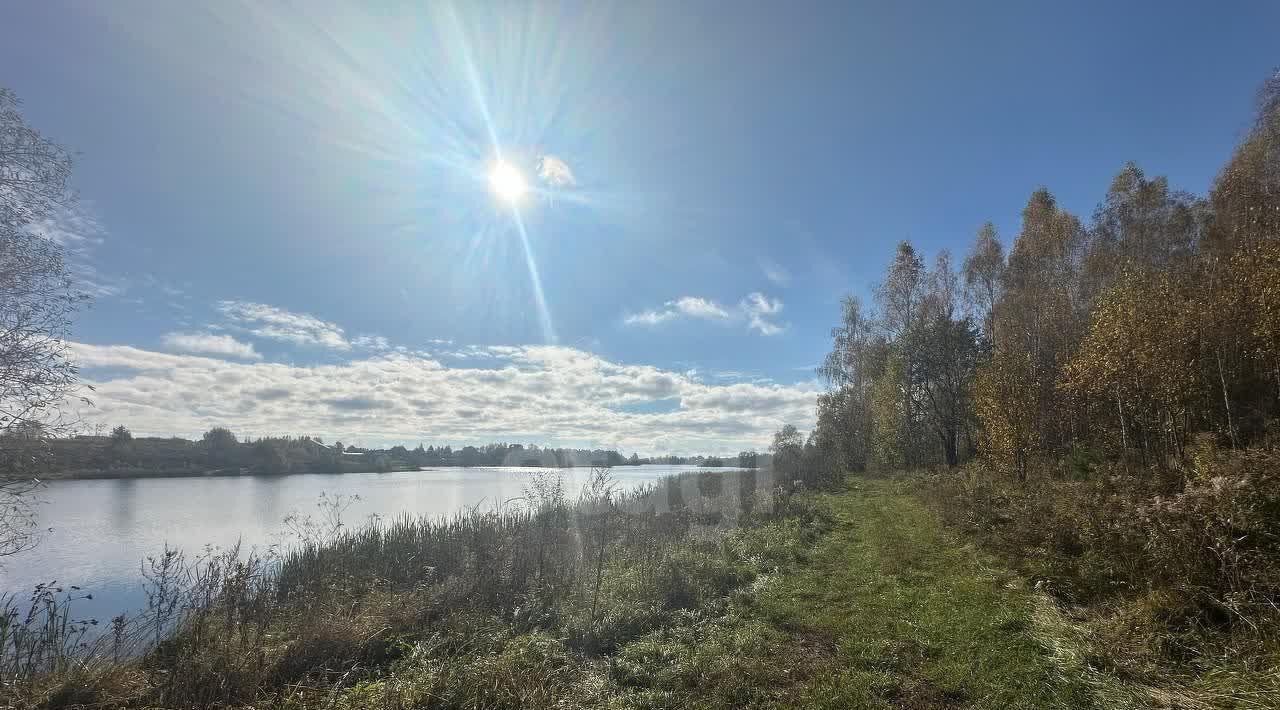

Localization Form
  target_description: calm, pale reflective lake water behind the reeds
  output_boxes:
[0,466,737,620]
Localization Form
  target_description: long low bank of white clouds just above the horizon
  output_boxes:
[73,344,817,453]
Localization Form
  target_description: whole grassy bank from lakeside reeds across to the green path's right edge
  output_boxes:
[0,472,1274,710]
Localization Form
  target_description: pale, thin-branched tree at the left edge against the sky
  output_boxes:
[0,88,87,556]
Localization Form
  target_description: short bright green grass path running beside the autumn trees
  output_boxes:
[756,481,1097,709]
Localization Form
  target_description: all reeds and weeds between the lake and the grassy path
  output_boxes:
[0,472,798,707]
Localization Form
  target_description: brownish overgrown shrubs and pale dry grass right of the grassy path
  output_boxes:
[915,445,1280,709]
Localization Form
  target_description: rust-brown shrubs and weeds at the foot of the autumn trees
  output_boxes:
[920,441,1280,661]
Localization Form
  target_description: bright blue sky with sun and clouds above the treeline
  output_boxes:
[0,1,1280,453]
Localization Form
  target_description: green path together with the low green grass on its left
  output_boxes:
[284,481,1131,709]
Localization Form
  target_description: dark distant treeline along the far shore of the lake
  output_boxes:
[0,425,759,477]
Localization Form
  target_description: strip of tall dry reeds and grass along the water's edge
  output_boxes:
[0,471,780,707]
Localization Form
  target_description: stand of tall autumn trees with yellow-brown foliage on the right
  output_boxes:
[819,68,1280,480]
